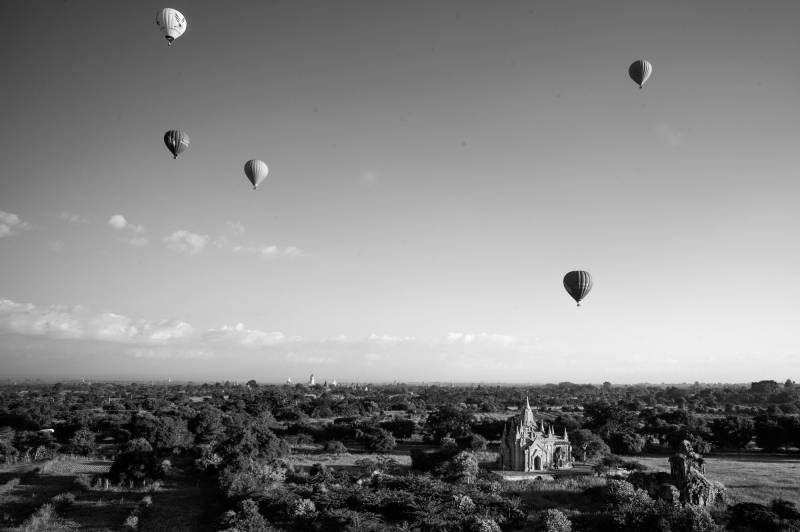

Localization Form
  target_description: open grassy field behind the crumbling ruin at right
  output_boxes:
[632,454,800,506]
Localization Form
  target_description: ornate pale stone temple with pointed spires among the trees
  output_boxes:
[500,398,572,471]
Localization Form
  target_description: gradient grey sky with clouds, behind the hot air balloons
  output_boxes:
[0,0,800,383]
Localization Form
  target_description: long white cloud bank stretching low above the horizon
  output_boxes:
[0,298,554,378]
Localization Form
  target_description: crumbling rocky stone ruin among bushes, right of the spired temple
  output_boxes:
[628,440,726,506]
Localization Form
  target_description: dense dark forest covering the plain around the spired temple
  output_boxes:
[0,380,800,531]
